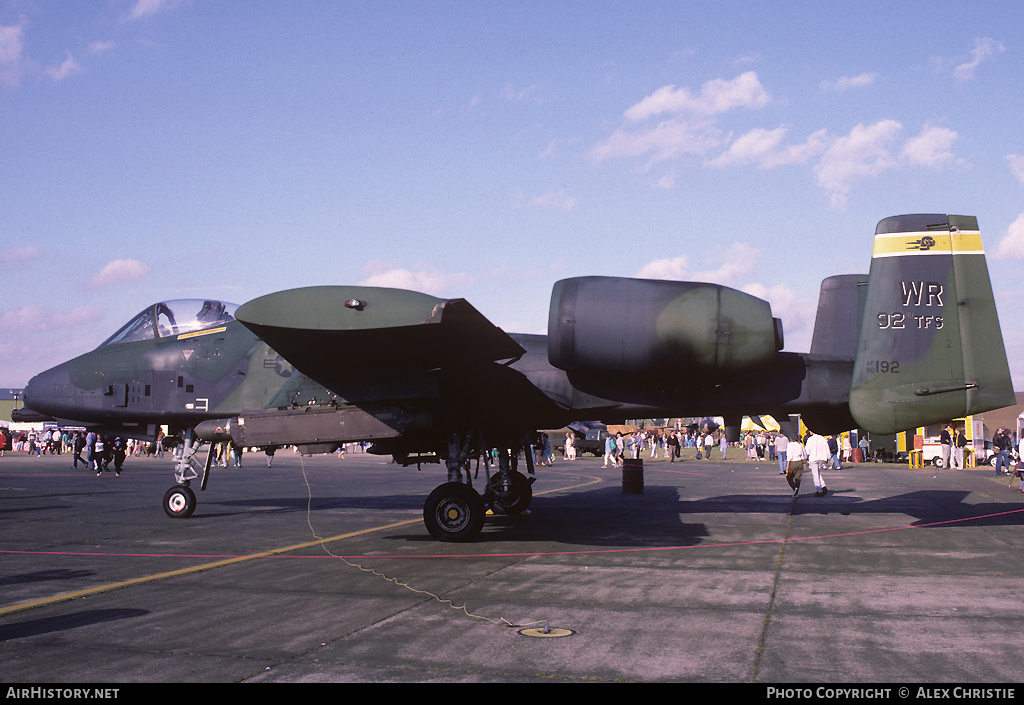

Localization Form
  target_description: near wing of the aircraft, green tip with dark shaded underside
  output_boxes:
[236,287,564,445]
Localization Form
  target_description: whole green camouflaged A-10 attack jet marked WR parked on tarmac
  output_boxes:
[18,215,1015,541]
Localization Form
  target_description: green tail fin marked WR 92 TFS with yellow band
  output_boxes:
[850,215,1016,433]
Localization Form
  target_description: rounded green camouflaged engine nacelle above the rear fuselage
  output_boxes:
[548,277,782,377]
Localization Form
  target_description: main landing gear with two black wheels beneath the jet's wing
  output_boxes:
[423,432,536,542]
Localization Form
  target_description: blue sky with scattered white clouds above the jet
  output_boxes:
[0,0,1024,389]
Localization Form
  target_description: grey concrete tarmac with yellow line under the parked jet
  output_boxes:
[0,442,1024,684]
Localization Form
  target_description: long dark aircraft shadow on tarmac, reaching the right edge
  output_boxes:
[201,479,1024,546]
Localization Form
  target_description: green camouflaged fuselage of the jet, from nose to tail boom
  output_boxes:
[25,313,852,438]
